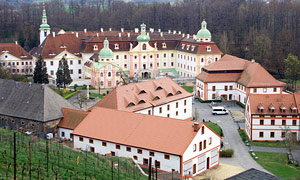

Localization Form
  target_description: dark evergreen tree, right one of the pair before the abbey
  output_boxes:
[56,57,73,88]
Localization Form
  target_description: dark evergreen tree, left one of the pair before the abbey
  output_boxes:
[33,55,49,84]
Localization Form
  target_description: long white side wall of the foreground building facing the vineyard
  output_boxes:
[74,135,180,172]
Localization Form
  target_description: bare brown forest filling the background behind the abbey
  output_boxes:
[0,0,300,78]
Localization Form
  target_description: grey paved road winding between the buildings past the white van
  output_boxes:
[193,100,268,172]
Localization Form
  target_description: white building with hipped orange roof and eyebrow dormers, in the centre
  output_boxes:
[95,78,193,120]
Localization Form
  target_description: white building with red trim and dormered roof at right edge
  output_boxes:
[245,93,300,141]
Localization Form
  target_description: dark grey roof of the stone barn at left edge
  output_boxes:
[0,79,74,122]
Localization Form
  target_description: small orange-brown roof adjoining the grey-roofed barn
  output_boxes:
[57,108,89,129]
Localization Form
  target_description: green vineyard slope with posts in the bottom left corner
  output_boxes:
[0,128,147,180]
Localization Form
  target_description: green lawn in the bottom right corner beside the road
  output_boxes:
[255,152,300,179]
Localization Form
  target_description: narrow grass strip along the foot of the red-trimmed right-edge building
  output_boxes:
[238,129,285,148]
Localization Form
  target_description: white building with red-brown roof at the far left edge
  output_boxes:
[0,41,35,75]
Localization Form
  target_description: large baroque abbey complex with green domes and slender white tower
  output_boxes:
[30,7,222,88]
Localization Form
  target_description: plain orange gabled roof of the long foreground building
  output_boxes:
[72,107,203,155]
